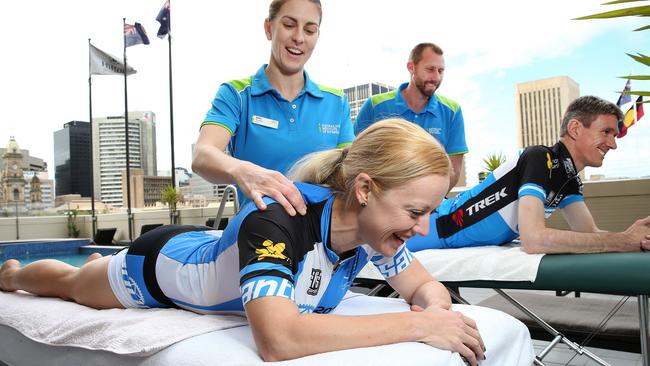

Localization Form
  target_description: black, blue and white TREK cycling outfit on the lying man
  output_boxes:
[406,142,584,251]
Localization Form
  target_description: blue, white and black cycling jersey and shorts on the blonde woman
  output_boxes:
[111,183,413,313]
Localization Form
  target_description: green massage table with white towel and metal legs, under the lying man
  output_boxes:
[356,244,650,366]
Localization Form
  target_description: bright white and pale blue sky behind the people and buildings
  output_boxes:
[0,0,650,184]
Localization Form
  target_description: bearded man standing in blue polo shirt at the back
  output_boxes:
[354,43,467,189]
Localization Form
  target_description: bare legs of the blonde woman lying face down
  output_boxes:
[0,256,123,309]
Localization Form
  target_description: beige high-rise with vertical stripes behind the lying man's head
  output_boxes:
[515,76,580,148]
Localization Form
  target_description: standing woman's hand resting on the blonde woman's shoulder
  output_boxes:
[235,162,307,216]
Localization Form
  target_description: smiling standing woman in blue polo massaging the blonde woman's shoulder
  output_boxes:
[192,0,354,215]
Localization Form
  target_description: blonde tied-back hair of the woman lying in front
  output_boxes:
[288,118,451,207]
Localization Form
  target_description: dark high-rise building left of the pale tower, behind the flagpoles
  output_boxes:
[54,121,92,197]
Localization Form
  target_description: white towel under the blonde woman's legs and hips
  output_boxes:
[0,291,248,356]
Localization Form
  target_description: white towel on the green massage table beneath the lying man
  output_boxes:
[357,244,543,282]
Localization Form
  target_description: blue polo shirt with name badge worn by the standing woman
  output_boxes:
[201,65,354,203]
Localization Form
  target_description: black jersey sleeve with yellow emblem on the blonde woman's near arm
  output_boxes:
[237,204,295,305]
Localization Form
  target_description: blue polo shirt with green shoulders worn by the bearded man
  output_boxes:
[354,83,468,155]
